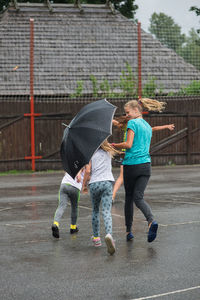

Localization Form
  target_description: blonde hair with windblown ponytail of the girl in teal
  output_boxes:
[124,98,166,112]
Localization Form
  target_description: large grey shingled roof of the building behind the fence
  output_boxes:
[0,5,200,95]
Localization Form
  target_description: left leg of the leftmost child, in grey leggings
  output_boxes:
[54,184,68,226]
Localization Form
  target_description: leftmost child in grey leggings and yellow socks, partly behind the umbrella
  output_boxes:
[51,169,85,238]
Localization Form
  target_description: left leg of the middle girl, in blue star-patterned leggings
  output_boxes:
[89,182,101,237]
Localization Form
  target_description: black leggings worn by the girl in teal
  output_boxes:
[124,163,153,232]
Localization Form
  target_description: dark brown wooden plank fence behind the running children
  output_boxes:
[0,97,200,171]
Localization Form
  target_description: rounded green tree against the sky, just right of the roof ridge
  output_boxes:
[149,13,185,51]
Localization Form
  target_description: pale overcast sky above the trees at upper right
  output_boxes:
[135,0,200,34]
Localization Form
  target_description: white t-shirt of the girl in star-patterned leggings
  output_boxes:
[89,148,115,184]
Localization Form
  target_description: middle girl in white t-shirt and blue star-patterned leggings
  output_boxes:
[85,140,119,255]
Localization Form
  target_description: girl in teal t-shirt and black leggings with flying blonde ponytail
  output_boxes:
[112,99,164,242]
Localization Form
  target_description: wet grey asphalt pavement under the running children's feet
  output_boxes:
[0,166,200,300]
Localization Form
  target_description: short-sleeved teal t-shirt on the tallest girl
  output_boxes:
[123,119,152,165]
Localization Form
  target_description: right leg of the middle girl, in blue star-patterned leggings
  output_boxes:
[99,181,112,235]
